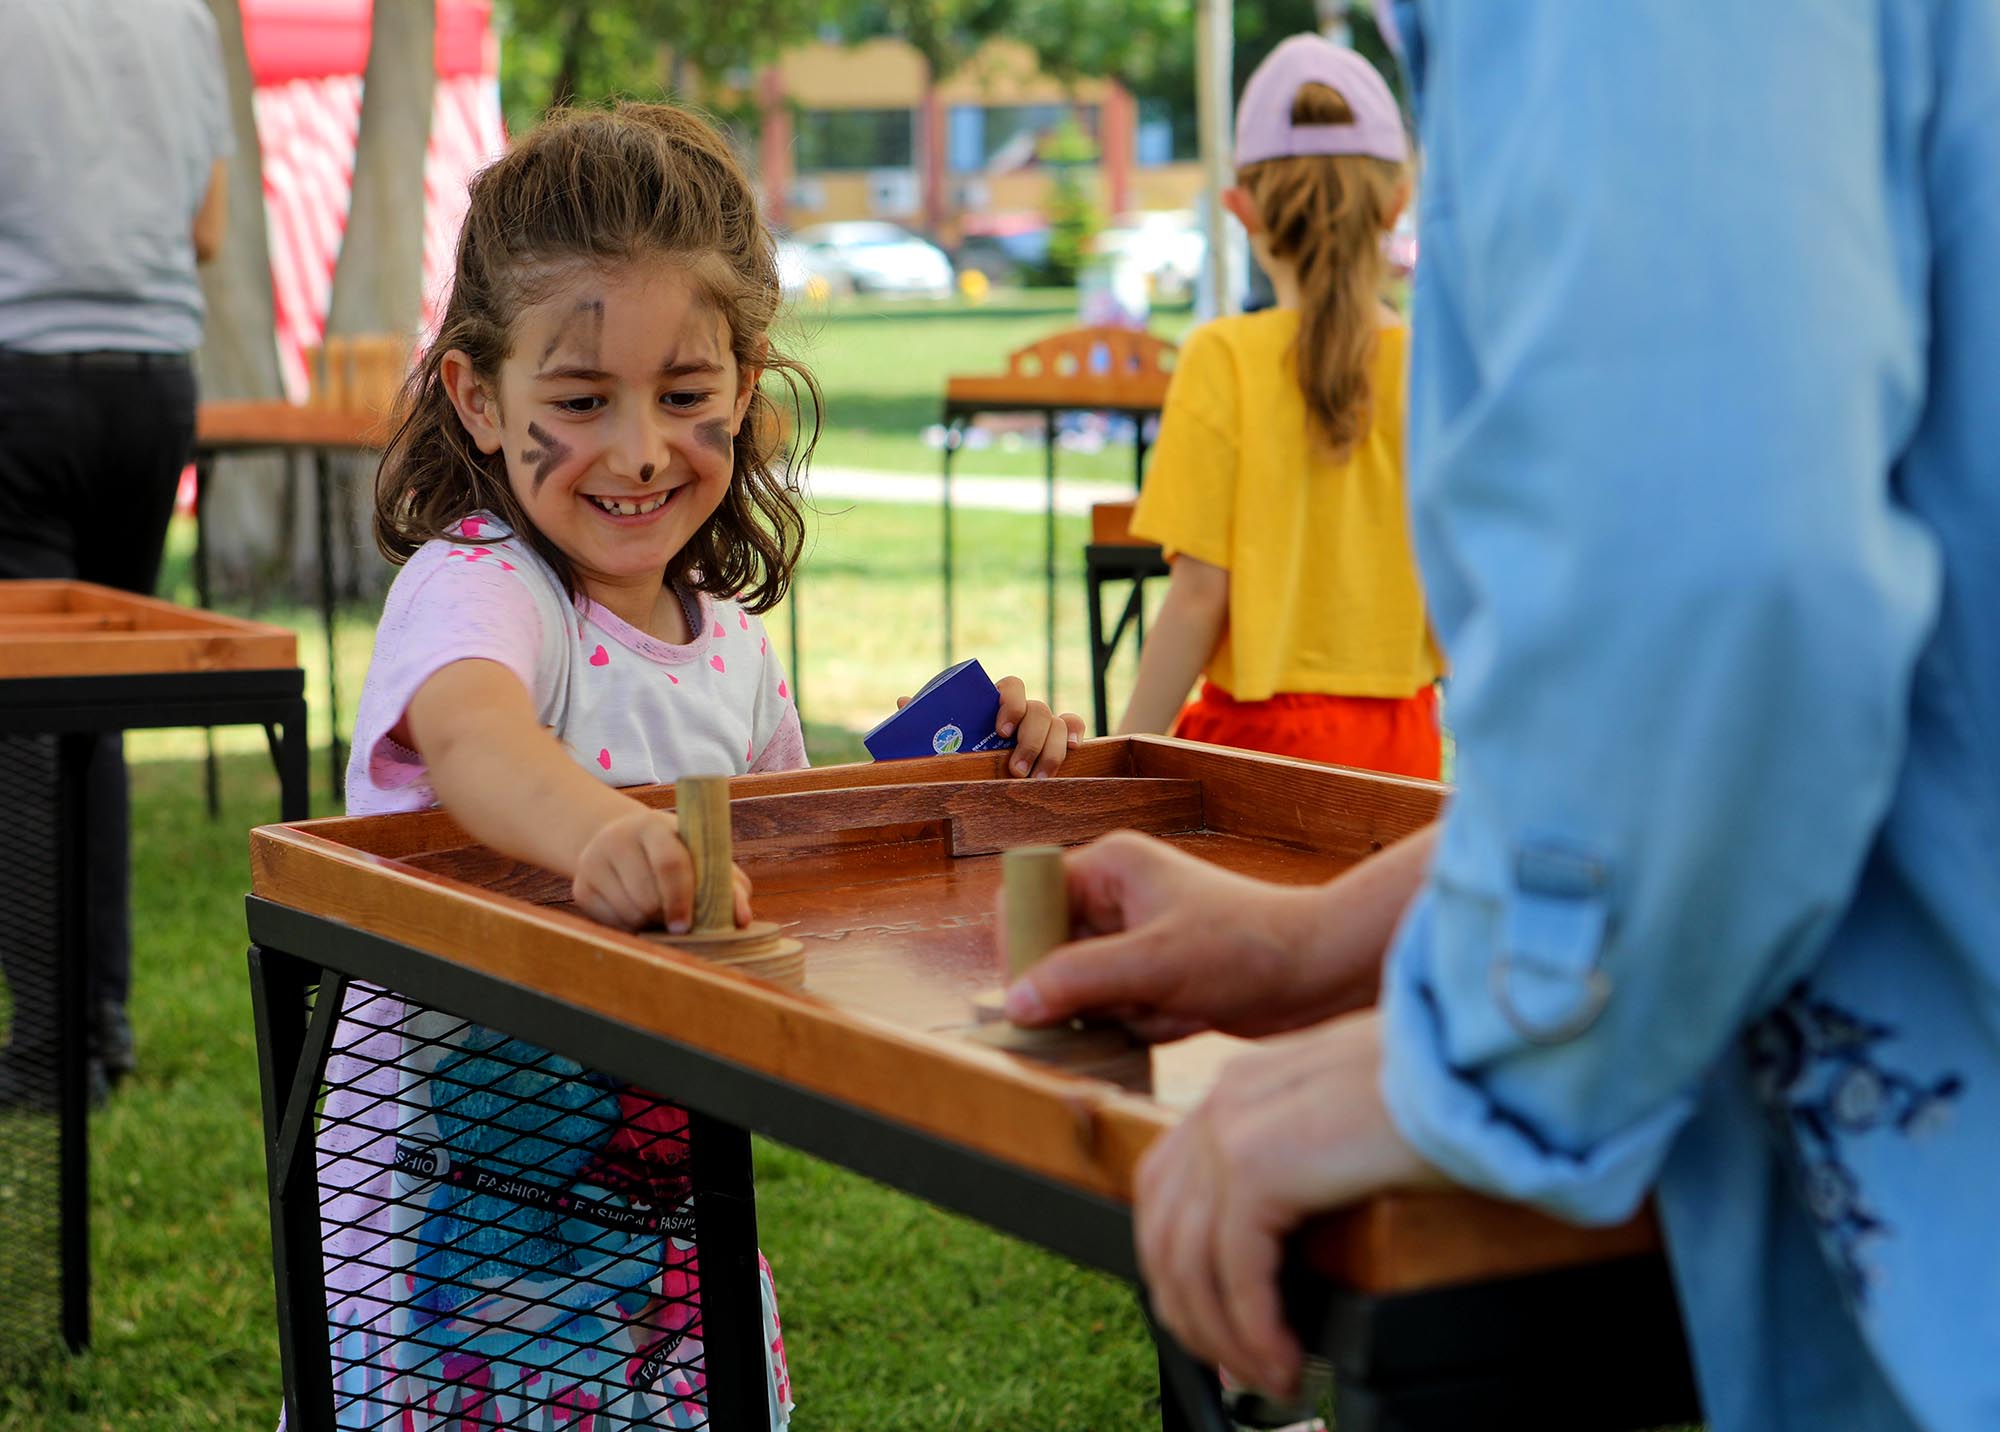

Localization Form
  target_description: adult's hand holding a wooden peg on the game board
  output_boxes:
[1006,826,1434,1040]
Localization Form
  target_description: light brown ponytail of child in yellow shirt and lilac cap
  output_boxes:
[1236,84,1406,454]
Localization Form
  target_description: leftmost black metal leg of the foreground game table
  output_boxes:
[250,946,346,1432]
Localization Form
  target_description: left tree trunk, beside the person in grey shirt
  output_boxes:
[198,0,286,592]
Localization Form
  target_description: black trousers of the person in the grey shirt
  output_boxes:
[0,350,194,1040]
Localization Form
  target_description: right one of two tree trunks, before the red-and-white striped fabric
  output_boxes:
[322,0,438,600]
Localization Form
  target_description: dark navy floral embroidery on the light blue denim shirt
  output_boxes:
[1746,984,1964,1302]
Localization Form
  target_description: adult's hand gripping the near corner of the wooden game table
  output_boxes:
[1134,1012,1446,1396]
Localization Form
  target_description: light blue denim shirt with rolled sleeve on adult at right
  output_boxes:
[1382,0,2000,1432]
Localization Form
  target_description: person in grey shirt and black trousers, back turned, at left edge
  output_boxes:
[0,0,232,1094]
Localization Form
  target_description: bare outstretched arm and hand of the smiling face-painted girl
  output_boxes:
[396,660,750,930]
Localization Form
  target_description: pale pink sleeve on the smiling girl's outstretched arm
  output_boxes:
[348,542,542,816]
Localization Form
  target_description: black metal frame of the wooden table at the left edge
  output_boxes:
[0,666,312,1352]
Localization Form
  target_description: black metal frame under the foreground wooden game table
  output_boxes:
[248,896,1700,1432]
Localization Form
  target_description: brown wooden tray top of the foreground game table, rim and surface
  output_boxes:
[252,736,1656,1292]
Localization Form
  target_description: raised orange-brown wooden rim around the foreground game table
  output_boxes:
[250,736,1658,1294]
